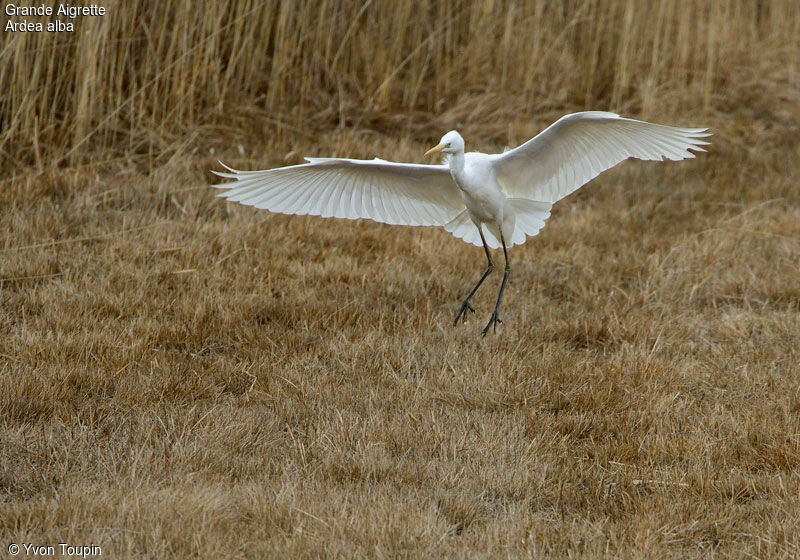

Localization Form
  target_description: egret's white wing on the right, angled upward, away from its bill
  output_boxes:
[493,111,710,202]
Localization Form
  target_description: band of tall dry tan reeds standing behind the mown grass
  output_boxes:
[0,1,800,166]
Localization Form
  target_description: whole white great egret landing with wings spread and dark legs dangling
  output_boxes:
[213,111,710,335]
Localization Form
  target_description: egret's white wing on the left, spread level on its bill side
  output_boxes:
[212,158,464,226]
